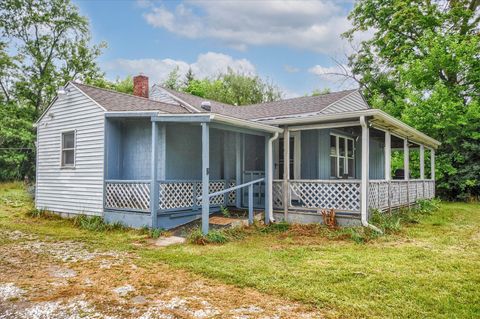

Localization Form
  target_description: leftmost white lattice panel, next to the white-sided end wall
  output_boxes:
[104,180,150,212]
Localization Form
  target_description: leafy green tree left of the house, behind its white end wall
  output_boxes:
[0,0,104,180]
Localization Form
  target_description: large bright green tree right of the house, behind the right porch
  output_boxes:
[344,0,480,199]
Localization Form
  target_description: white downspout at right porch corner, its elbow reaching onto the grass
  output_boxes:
[360,116,383,234]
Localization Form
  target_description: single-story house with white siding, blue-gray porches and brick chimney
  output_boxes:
[35,75,440,232]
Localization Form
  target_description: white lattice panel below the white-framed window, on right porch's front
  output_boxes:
[288,180,360,212]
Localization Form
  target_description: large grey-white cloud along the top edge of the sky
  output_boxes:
[144,0,366,54]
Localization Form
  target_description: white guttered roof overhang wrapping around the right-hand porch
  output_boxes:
[262,109,441,149]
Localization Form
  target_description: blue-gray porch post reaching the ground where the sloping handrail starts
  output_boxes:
[202,123,210,235]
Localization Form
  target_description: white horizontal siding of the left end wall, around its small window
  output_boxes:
[36,85,104,215]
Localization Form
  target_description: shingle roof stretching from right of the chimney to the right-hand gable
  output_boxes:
[164,88,357,120]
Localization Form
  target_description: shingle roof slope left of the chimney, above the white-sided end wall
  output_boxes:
[72,82,189,113]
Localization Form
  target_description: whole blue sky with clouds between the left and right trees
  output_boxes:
[74,0,355,97]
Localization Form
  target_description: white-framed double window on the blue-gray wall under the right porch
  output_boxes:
[330,134,355,178]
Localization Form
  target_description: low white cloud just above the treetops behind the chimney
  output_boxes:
[103,52,256,83]
